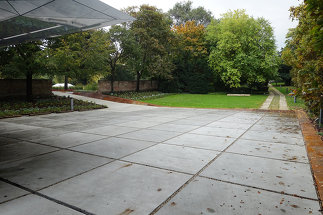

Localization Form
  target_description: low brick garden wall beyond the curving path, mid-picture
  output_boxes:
[98,80,158,93]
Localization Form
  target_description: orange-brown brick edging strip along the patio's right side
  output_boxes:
[295,110,323,211]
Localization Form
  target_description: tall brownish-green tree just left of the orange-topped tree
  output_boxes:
[124,5,172,91]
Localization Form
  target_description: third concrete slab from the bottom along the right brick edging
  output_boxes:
[227,139,309,163]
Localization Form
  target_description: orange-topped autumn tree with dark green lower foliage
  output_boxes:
[168,21,209,93]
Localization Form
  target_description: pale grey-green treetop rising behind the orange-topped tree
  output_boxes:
[168,1,213,26]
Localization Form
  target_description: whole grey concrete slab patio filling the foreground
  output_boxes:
[0,98,321,215]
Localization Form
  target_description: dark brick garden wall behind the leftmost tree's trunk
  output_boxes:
[0,79,52,98]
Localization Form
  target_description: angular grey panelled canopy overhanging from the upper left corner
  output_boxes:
[0,0,134,46]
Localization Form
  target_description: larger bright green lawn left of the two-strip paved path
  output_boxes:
[141,93,268,109]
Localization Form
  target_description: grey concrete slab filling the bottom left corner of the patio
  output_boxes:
[0,194,83,215]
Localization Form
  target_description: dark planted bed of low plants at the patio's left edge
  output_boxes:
[0,96,106,118]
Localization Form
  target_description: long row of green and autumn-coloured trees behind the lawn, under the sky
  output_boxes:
[0,1,280,98]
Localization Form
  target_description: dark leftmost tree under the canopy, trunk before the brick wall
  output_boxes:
[0,41,44,101]
